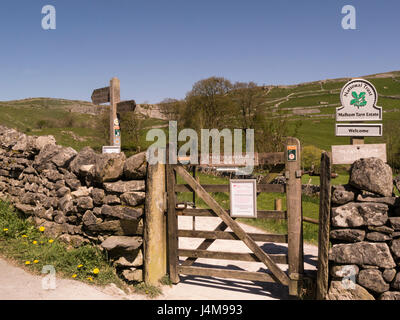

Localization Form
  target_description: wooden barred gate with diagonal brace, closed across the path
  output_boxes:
[166,138,304,296]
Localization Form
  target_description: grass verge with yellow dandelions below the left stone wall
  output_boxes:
[0,201,124,289]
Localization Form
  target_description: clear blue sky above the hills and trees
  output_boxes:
[0,0,400,103]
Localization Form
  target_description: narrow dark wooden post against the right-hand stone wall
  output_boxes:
[317,152,331,300]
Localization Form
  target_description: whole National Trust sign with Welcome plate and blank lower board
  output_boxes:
[332,79,386,164]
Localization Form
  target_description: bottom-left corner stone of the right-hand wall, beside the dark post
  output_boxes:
[327,281,375,300]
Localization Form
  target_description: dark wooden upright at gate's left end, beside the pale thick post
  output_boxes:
[166,148,179,284]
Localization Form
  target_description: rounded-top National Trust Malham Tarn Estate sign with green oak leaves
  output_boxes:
[336,79,382,121]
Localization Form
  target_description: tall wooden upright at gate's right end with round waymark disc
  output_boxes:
[285,137,304,296]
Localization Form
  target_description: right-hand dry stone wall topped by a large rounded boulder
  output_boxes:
[328,158,400,300]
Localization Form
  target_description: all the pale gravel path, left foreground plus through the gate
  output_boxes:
[0,217,318,300]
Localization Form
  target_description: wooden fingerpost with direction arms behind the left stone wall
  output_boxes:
[91,77,136,153]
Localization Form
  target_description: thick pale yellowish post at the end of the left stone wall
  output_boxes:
[143,163,167,285]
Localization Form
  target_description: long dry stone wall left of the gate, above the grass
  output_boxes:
[0,126,147,281]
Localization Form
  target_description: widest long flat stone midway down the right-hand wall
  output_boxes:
[329,242,396,269]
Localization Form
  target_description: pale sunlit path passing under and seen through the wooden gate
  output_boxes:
[159,217,318,300]
